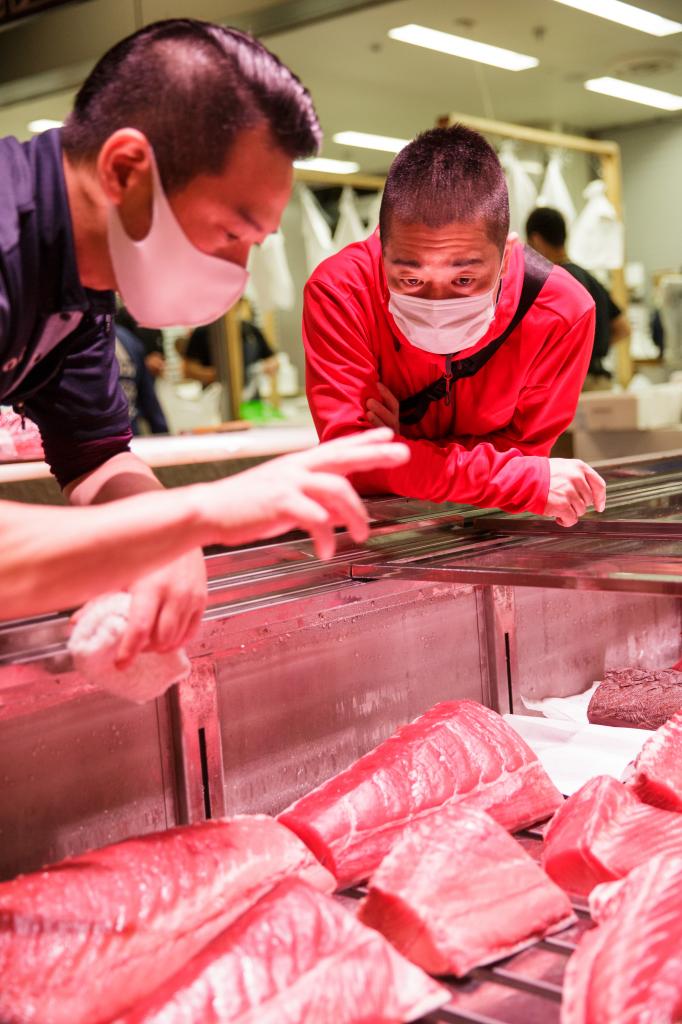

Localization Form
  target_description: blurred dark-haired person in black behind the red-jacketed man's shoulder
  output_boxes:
[525,206,630,390]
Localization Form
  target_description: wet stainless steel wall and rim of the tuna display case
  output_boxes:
[0,456,682,877]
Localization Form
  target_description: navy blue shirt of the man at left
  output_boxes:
[0,129,131,486]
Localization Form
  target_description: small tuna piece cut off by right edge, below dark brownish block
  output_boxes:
[629,714,682,811]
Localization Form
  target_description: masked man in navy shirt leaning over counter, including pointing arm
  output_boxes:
[0,18,406,665]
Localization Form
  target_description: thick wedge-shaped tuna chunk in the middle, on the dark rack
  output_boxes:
[359,804,576,977]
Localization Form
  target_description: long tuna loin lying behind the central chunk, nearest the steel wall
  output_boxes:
[280,700,562,886]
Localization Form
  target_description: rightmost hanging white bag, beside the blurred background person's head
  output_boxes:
[568,180,625,271]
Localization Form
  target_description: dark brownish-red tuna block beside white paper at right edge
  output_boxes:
[588,669,682,729]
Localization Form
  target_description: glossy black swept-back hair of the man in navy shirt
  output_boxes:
[61,17,322,190]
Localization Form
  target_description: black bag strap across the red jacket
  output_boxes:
[399,246,552,426]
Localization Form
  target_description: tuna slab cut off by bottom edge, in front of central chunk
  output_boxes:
[117,879,450,1024]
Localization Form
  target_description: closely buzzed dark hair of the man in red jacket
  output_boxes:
[379,125,509,251]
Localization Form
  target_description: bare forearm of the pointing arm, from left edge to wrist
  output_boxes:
[0,487,212,620]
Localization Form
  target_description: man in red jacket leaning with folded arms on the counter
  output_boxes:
[303,125,605,526]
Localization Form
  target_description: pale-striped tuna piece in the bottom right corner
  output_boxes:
[561,854,682,1024]
